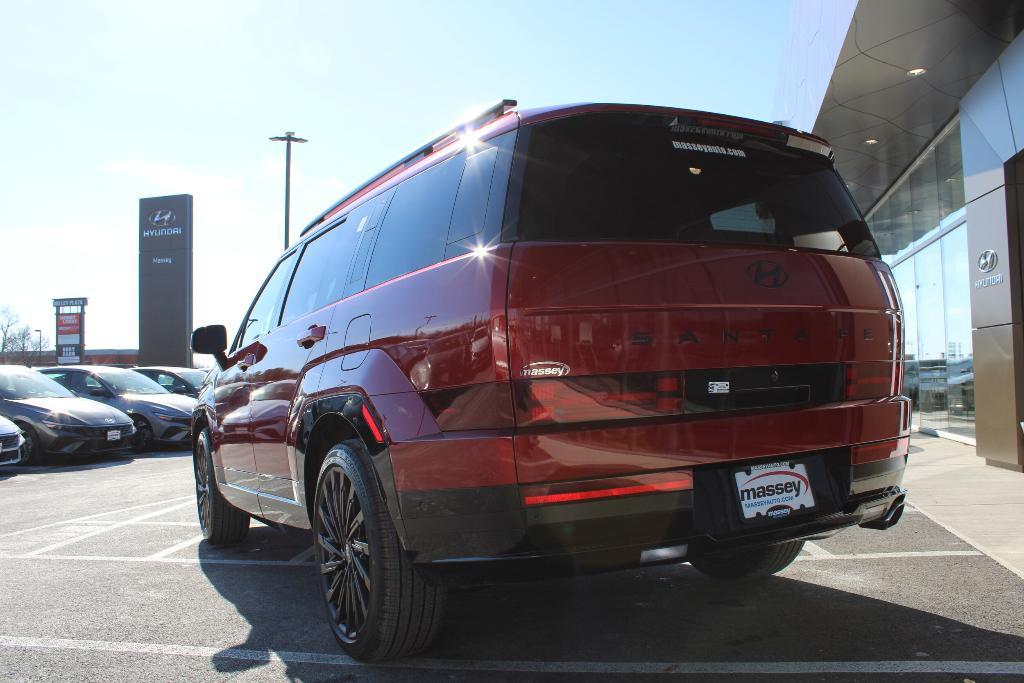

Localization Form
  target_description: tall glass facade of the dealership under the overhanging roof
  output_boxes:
[867,123,974,437]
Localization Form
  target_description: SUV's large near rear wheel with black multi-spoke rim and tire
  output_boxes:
[312,443,446,661]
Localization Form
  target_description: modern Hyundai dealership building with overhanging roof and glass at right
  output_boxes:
[773,0,1024,471]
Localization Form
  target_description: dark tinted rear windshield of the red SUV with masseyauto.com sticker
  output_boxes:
[513,114,879,257]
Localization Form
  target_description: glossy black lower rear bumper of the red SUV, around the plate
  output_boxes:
[399,449,906,580]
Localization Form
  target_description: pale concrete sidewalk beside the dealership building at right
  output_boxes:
[903,434,1024,579]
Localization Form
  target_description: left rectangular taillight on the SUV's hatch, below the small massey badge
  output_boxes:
[515,373,683,425]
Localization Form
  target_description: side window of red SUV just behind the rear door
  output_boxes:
[366,154,465,287]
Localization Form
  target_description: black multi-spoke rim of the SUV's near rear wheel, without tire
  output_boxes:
[315,467,373,643]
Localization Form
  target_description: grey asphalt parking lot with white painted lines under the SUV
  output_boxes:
[0,446,1024,681]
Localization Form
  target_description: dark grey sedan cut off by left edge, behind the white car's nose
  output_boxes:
[0,366,135,465]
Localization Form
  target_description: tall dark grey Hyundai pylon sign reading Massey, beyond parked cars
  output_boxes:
[138,195,193,368]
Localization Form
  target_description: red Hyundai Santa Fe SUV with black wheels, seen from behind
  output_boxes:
[193,100,910,659]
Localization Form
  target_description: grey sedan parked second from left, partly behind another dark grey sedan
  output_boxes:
[40,366,196,451]
